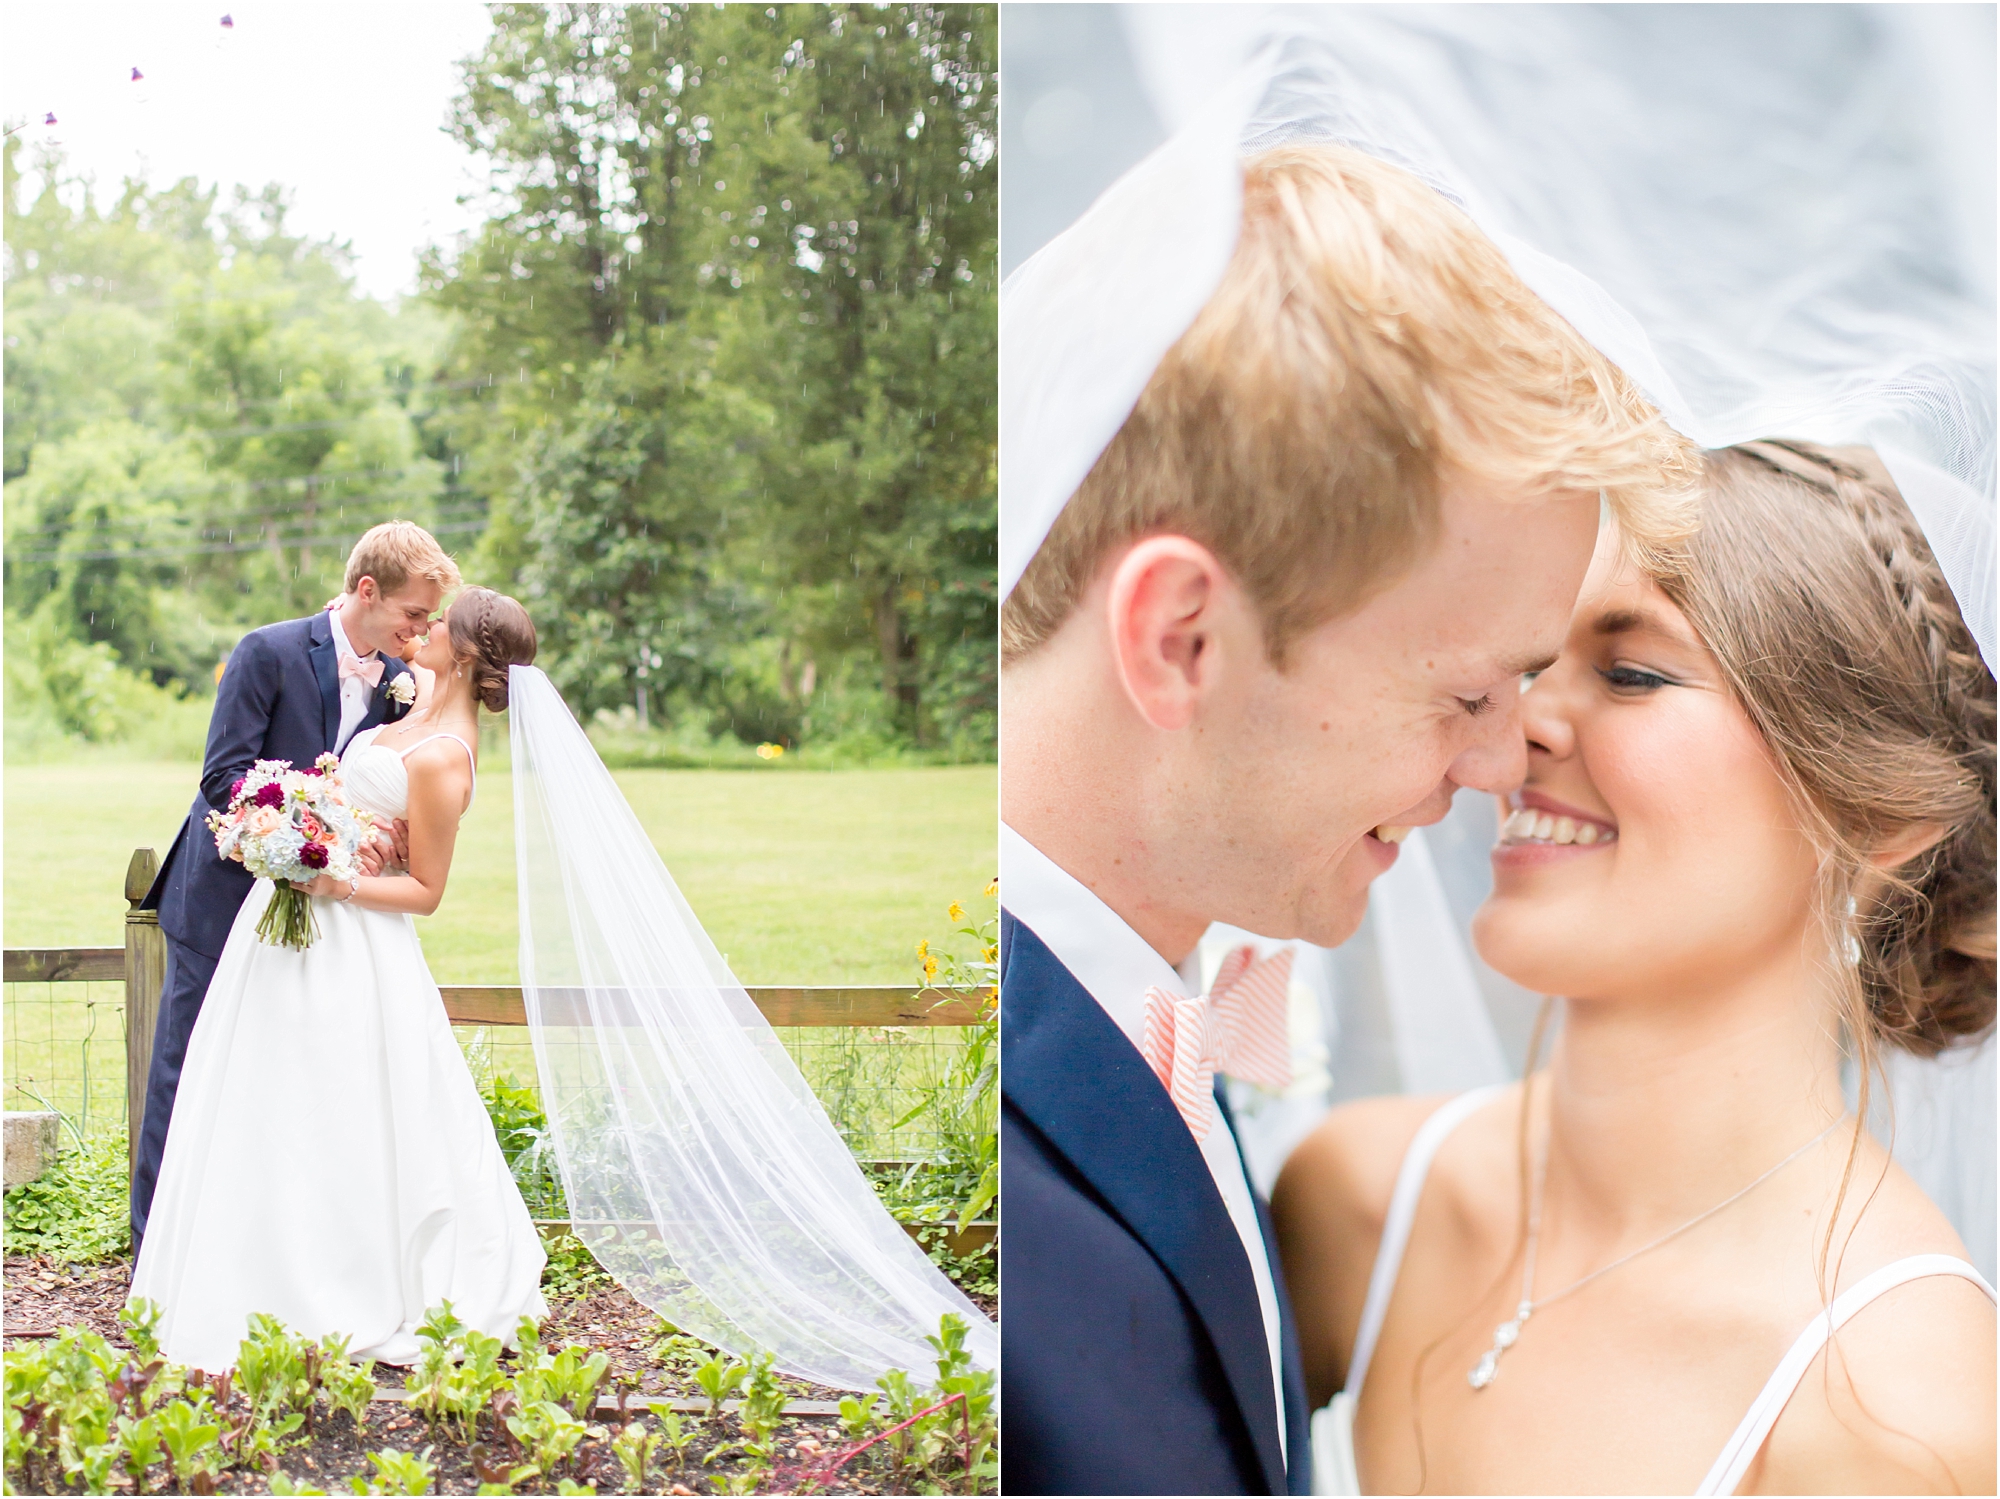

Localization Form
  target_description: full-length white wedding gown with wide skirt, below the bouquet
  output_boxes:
[132,730,546,1369]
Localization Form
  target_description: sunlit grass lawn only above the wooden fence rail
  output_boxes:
[4,761,996,983]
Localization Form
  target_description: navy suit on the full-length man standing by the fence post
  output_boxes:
[132,614,410,1245]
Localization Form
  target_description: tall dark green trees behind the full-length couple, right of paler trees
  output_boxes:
[426,4,998,755]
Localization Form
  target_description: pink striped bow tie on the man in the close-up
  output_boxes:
[1140,943,1292,1139]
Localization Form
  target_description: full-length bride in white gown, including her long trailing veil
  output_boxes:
[132,588,998,1389]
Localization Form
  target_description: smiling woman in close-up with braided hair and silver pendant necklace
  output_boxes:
[1274,442,1996,1493]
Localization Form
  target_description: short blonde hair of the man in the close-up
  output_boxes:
[1000,144,1700,666]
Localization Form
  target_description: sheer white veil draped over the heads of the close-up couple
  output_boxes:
[1000,4,1996,1275]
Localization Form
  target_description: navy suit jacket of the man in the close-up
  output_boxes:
[1000,911,1312,1495]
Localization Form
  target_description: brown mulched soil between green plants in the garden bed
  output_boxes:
[0,1255,994,1495]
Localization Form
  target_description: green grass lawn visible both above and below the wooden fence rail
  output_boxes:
[4,755,996,1155]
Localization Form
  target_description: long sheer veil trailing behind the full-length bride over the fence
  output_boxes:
[508,666,1000,1389]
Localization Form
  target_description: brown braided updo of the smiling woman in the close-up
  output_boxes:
[1660,442,1994,1077]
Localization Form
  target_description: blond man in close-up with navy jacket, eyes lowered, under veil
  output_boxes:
[1000,146,1692,1495]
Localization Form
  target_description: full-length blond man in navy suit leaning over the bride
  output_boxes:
[132,520,458,1259]
